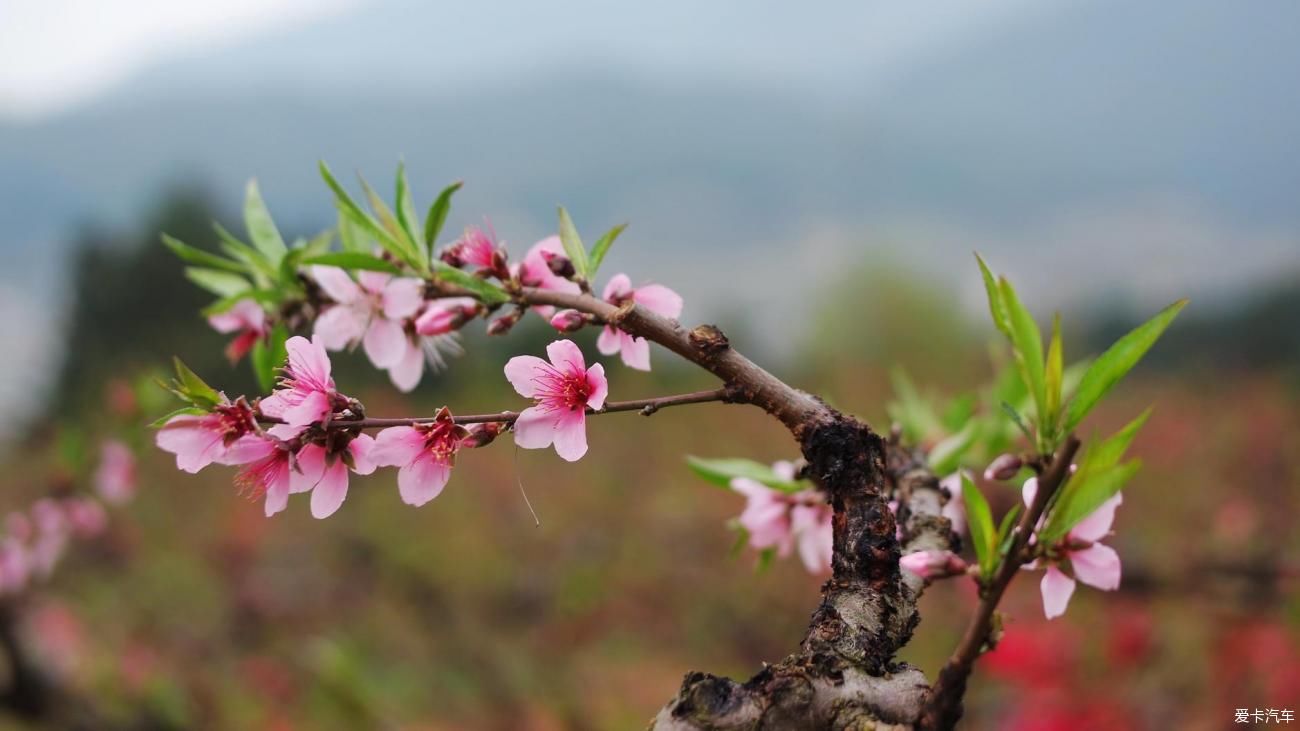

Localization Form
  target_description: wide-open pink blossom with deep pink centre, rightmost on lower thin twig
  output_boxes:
[506,339,610,462]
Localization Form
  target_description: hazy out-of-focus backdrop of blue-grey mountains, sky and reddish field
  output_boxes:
[0,0,1300,730]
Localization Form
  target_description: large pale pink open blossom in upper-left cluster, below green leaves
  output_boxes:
[311,265,424,392]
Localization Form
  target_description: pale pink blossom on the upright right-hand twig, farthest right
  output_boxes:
[1022,477,1123,619]
